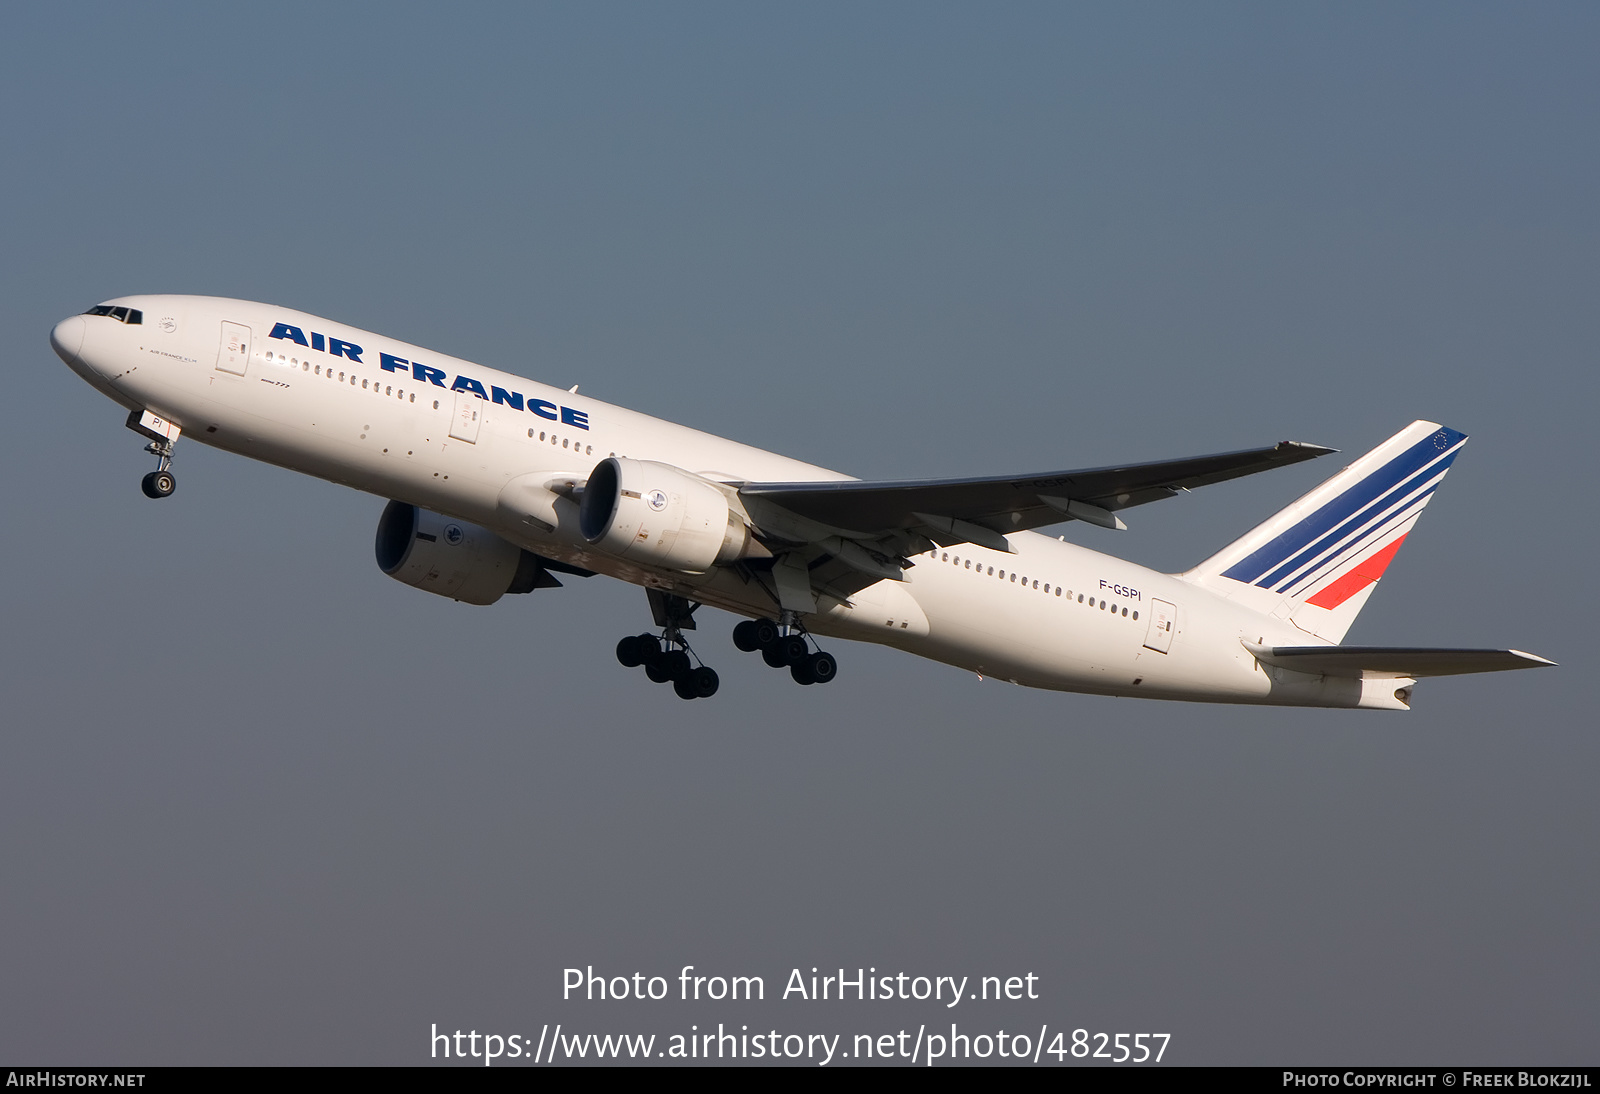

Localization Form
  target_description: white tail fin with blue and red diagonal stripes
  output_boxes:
[1182,422,1467,641]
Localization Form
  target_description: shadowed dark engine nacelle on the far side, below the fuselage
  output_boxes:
[374,501,558,605]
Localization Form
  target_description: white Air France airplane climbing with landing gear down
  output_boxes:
[50,296,1555,710]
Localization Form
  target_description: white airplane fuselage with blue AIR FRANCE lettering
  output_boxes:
[53,296,1362,707]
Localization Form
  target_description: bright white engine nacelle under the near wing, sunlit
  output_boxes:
[578,456,750,574]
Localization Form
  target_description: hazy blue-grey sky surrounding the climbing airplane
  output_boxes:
[0,3,1600,1064]
